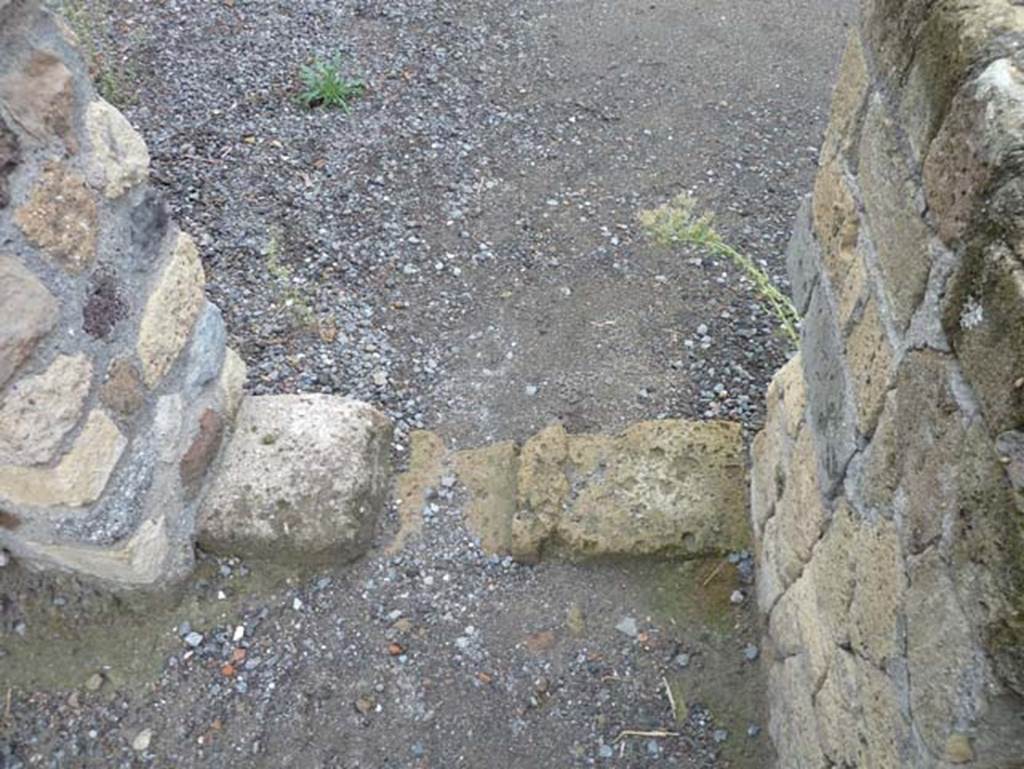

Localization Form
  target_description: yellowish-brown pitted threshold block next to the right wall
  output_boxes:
[460,420,750,561]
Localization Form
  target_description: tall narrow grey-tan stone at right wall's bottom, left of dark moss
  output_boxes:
[906,548,985,756]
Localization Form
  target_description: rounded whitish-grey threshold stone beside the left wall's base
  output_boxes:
[199,395,391,561]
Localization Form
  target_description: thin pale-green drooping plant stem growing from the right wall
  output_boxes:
[640,193,800,346]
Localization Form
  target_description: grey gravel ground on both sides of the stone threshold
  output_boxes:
[0,0,853,769]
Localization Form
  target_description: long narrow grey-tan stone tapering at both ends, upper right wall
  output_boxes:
[859,97,931,332]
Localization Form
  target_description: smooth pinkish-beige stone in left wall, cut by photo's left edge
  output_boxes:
[0,254,59,386]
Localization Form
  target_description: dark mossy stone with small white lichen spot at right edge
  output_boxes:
[946,245,1024,433]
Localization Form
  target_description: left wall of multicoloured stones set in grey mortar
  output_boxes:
[0,0,245,587]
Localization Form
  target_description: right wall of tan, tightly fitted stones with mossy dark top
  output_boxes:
[752,0,1024,769]
